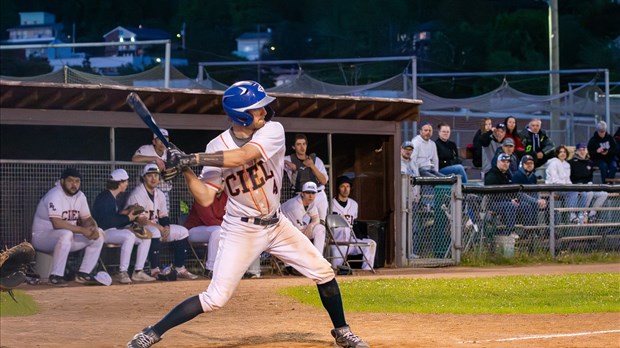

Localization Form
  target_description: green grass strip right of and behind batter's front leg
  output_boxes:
[279,273,620,314]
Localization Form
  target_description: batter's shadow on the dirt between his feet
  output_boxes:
[182,330,334,348]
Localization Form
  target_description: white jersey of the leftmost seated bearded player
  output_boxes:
[32,183,90,233]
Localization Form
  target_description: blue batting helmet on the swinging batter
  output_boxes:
[222,81,276,127]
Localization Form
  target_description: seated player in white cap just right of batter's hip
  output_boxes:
[282,181,325,254]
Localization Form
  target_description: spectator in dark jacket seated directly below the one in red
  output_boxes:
[484,153,519,237]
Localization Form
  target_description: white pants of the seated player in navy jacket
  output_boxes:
[105,228,151,272]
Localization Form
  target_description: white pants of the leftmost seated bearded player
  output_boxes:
[32,229,104,277]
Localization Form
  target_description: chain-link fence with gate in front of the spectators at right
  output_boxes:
[403,177,620,266]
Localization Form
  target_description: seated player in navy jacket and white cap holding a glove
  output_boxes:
[93,169,155,284]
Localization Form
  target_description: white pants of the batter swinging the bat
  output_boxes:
[199,215,334,312]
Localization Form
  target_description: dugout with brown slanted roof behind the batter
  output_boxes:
[0,80,422,266]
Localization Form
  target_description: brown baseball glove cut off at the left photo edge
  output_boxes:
[0,242,35,302]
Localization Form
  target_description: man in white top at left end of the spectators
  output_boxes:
[411,123,445,177]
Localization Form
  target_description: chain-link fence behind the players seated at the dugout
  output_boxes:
[0,160,306,276]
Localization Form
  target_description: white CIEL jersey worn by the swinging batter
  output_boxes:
[201,121,285,217]
